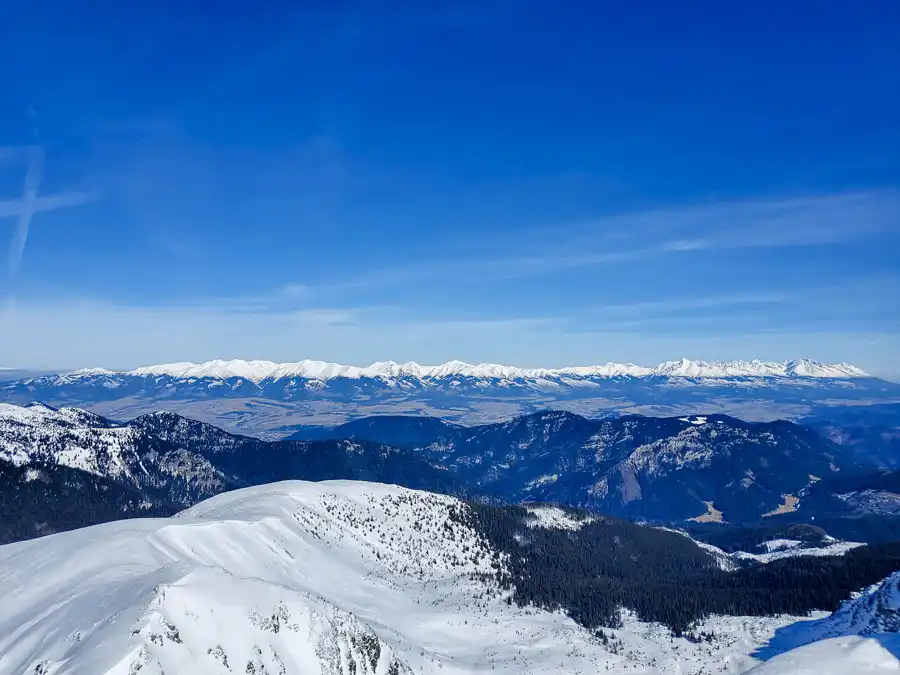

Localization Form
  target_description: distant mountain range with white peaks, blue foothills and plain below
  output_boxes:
[0,359,900,438]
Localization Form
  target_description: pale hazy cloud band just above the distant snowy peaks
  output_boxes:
[0,299,898,372]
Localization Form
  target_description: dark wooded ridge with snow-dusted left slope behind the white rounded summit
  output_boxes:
[0,404,468,539]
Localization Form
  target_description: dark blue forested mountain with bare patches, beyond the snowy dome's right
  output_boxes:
[292,412,866,521]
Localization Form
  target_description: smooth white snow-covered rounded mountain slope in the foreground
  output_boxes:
[0,481,816,675]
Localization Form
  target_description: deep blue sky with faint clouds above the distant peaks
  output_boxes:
[0,0,900,376]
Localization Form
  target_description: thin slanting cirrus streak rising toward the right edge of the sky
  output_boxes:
[308,190,900,291]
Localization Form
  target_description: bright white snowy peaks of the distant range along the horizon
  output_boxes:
[66,359,868,382]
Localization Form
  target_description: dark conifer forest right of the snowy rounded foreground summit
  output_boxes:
[456,504,900,635]
